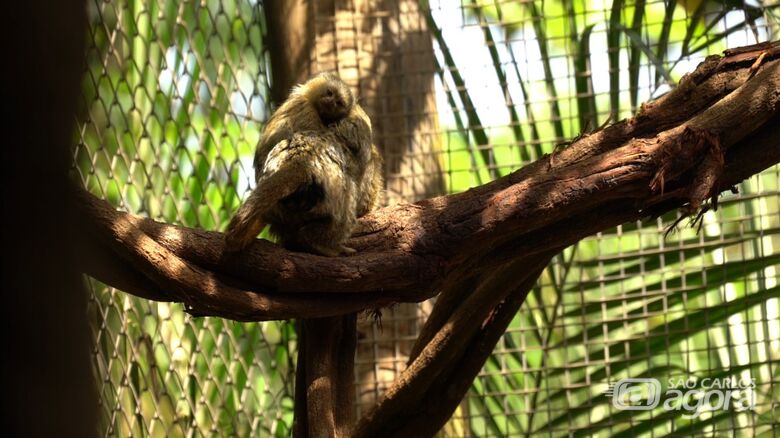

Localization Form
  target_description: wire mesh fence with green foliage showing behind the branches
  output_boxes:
[74,0,780,436]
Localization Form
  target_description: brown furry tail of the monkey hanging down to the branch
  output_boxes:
[225,161,310,252]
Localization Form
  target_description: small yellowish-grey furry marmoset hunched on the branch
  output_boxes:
[226,74,382,256]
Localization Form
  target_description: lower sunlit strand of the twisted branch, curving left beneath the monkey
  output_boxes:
[75,189,402,321]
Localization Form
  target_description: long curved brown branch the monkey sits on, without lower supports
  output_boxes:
[77,44,780,320]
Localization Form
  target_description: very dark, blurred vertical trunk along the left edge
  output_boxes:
[0,0,98,437]
